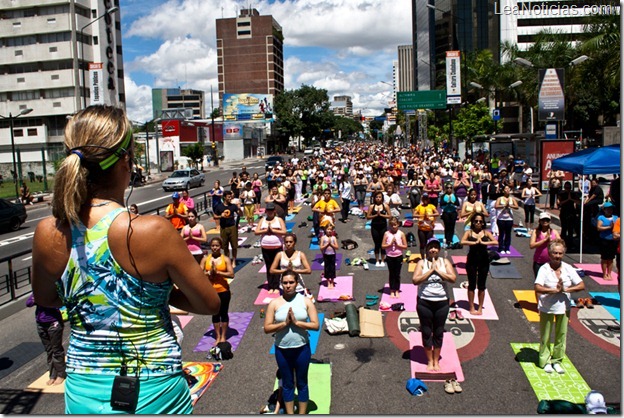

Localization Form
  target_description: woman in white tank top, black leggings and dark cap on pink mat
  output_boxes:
[412,237,457,371]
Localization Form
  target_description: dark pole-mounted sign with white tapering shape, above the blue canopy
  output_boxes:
[537,68,565,121]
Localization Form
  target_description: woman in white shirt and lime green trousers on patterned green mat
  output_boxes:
[535,239,585,374]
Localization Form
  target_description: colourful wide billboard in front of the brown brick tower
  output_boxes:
[223,93,273,121]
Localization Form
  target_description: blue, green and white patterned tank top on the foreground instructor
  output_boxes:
[57,208,182,375]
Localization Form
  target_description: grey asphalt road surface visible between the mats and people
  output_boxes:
[0,159,621,415]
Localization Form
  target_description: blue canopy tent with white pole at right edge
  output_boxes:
[552,144,621,263]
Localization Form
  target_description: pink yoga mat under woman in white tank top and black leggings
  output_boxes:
[408,332,464,382]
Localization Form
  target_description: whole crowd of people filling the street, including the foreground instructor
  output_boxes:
[28,106,619,413]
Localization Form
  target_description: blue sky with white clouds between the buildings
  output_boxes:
[120,0,412,122]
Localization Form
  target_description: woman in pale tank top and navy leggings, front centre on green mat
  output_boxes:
[264,270,319,414]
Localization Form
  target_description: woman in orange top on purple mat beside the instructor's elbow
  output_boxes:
[200,237,234,346]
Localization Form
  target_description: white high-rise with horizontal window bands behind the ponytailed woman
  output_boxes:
[0,0,126,177]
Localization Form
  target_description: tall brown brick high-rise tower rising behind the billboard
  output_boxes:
[217,9,284,100]
